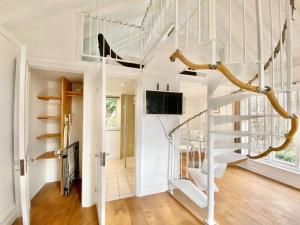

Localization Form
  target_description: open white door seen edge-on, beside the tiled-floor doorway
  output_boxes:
[95,59,107,225]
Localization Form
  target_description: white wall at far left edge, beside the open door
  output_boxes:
[0,34,18,225]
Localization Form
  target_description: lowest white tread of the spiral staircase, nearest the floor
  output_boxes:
[173,179,207,208]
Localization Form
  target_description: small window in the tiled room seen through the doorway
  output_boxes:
[106,97,120,130]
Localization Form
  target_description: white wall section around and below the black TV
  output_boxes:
[136,72,180,196]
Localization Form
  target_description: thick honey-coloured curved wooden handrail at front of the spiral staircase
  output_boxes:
[170,49,298,159]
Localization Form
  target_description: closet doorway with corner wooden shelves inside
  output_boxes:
[28,68,83,200]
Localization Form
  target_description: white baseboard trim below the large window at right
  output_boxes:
[239,160,300,189]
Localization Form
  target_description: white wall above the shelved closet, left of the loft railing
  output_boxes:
[16,11,80,60]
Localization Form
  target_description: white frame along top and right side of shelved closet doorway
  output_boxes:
[28,57,99,207]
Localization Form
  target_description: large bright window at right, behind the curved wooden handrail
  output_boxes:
[241,91,300,170]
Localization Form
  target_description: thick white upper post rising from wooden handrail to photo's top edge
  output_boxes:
[256,0,265,89]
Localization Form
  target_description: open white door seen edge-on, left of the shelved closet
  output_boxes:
[15,46,31,225]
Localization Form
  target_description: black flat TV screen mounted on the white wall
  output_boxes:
[146,91,182,115]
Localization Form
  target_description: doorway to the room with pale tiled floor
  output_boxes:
[106,77,136,201]
